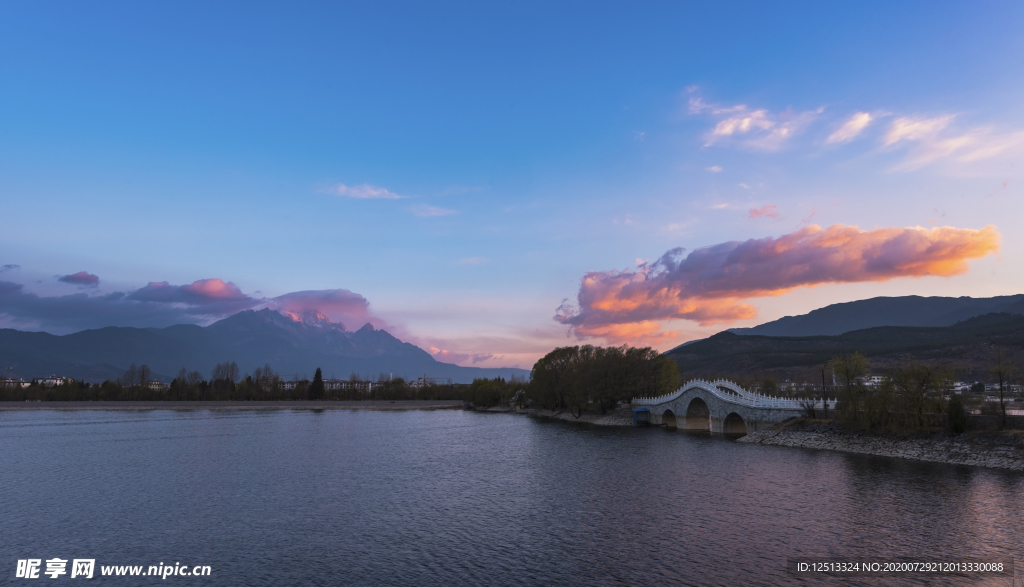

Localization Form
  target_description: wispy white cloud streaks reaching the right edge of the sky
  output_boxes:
[882,115,1024,171]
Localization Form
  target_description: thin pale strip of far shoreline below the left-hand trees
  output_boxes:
[0,400,465,412]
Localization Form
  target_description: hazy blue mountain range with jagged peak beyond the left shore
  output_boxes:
[0,309,529,383]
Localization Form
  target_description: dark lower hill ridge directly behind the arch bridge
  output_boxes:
[666,313,1024,382]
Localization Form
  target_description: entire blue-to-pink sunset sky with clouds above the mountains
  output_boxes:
[0,2,1024,369]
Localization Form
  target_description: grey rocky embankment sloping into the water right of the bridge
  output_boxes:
[737,421,1024,471]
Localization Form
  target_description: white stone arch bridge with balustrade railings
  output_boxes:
[632,379,836,434]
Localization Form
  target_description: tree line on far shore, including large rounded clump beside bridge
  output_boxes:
[2,345,680,407]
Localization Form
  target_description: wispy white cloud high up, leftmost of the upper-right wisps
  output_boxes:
[689,93,823,152]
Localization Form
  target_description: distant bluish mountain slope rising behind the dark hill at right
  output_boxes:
[729,294,1024,336]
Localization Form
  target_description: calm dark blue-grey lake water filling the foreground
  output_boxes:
[0,411,1024,586]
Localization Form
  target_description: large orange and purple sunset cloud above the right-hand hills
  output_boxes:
[554,224,1000,342]
